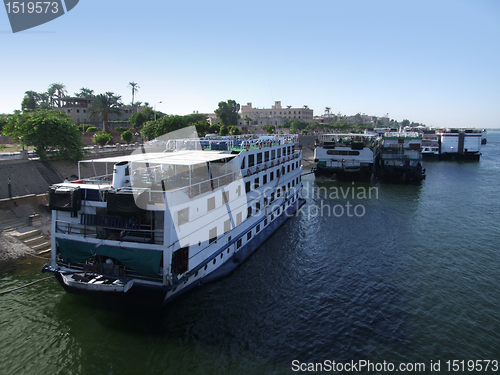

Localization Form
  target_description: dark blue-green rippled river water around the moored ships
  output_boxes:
[0,132,500,375]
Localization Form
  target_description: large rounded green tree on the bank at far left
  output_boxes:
[3,109,83,161]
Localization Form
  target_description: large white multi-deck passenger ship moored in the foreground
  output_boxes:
[43,131,304,305]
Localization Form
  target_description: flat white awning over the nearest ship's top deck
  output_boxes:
[82,151,235,166]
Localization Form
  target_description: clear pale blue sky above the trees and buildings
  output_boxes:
[0,0,500,128]
